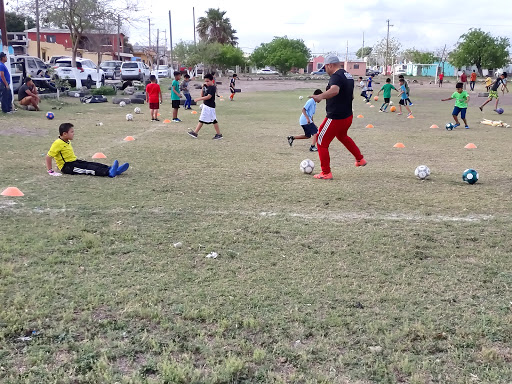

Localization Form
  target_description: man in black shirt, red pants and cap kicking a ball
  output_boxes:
[311,55,367,180]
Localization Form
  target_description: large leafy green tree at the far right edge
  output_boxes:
[449,28,510,76]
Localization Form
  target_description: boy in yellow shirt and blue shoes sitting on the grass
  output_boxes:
[46,123,130,177]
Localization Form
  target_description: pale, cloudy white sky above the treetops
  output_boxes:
[127,0,512,58]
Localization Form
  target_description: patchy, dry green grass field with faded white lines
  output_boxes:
[0,82,512,384]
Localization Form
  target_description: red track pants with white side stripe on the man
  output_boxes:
[317,116,363,173]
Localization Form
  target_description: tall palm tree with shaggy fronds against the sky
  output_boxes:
[196,8,238,45]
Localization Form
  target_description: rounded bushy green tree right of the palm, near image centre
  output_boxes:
[251,36,311,75]
